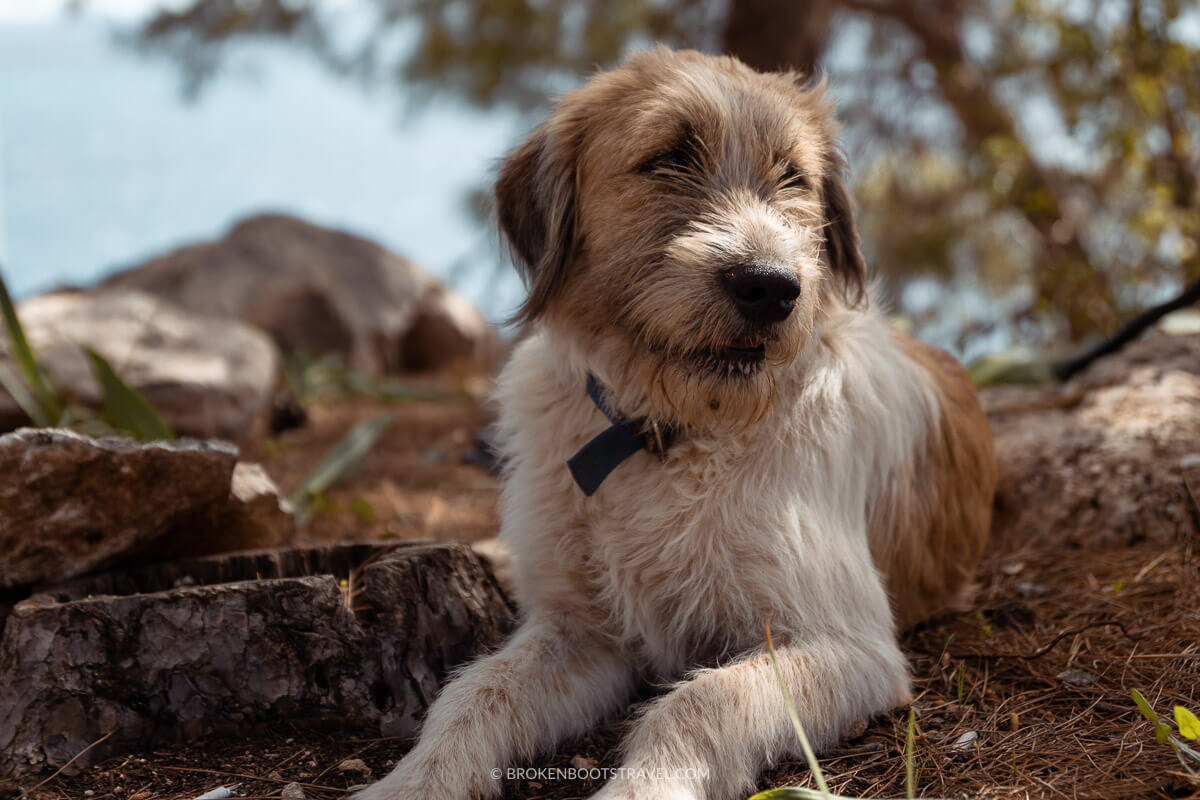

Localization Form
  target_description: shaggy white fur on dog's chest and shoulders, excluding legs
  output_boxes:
[499,314,929,674]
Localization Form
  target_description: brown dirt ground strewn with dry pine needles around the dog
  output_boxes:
[9,379,1200,800]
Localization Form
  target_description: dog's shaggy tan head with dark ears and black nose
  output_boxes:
[496,49,865,428]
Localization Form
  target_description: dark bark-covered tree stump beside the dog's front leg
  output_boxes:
[0,543,514,776]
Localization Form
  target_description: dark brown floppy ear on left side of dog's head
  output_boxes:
[496,122,576,323]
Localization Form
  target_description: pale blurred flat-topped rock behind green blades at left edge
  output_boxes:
[0,291,280,441]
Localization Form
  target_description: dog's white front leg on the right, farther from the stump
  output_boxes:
[595,634,908,800]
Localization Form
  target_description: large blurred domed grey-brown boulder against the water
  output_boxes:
[104,216,496,375]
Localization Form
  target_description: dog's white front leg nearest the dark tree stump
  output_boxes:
[355,618,632,800]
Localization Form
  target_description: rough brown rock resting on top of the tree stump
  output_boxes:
[0,428,296,594]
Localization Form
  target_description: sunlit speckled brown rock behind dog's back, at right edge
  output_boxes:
[983,335,1200,547]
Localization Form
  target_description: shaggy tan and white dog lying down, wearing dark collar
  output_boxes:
[358,49,996,800]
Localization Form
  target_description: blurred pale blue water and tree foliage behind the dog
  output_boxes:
[0,0,1200,360]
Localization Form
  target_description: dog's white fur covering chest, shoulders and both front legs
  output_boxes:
[359,299,940,800]
